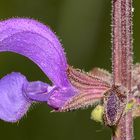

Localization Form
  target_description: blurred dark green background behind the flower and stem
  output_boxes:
[0,0,140,140]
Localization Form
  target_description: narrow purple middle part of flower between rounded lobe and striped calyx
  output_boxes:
[24,81,76,110]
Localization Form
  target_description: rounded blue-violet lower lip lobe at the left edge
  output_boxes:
[0,73,31,122]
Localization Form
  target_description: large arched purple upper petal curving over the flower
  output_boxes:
[0,18,69,87]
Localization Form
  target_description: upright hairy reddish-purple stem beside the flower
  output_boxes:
[112,0,133,140]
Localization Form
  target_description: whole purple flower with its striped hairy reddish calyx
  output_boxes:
[0,18,111,122]
